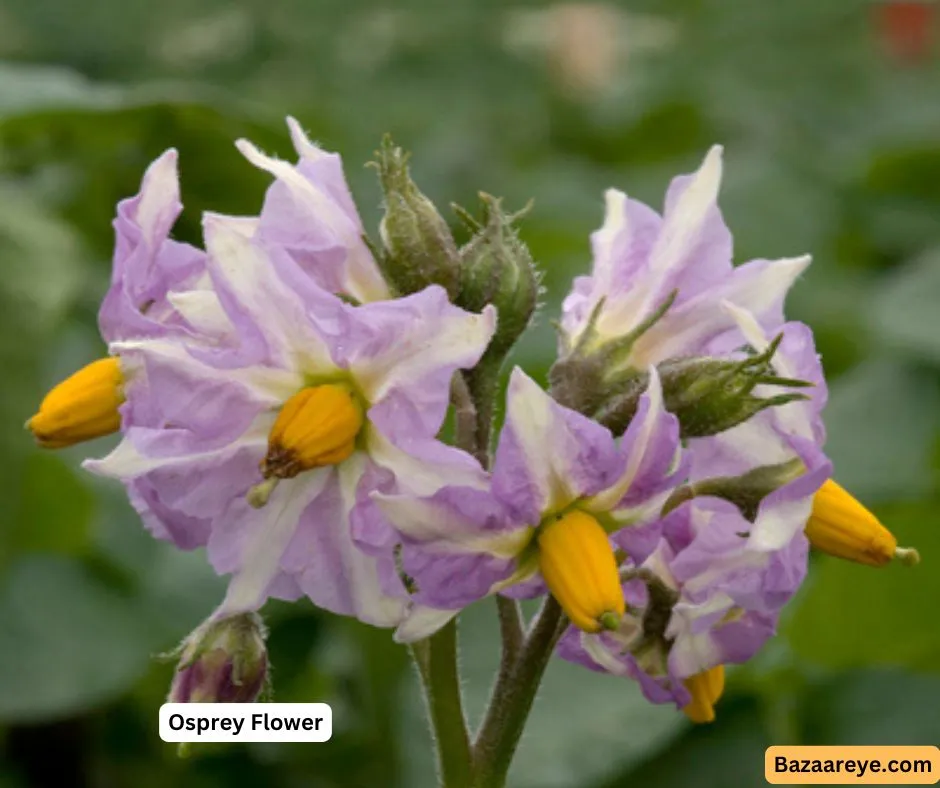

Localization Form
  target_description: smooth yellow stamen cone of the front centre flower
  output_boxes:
[538,511,626,632]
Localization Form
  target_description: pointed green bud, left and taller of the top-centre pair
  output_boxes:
[374,136,460,300]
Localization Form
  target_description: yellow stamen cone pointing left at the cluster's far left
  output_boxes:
[26,358,124,449]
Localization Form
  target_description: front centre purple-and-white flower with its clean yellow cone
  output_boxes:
[374,369,683,633]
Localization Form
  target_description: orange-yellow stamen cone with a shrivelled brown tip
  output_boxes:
[261,383,363,479]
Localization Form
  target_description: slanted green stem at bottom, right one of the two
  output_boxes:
[473,596,563,788]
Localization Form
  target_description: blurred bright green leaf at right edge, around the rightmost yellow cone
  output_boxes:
[783,500,940,670]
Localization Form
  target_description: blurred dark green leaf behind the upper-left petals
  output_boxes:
[0,97,294,255]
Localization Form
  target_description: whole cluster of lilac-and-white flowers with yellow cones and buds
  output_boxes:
[28,120,914,721]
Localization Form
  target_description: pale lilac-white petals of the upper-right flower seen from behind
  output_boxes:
[562,146,809,369]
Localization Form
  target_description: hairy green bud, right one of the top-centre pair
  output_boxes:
[454,194,541,359]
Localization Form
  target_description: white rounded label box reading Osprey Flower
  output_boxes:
[160,703,333,742]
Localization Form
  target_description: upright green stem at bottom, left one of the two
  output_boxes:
[412,620,472,788]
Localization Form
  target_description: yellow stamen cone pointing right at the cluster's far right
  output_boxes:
[806,479,920,566]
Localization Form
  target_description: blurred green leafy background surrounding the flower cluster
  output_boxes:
[0,0,940,788]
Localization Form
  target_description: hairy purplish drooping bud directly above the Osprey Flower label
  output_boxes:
[167,613,268,703]
